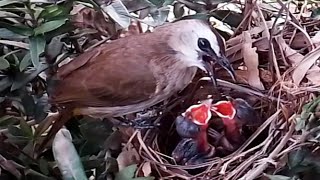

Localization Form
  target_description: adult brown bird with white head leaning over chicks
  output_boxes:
[40,19,235,152]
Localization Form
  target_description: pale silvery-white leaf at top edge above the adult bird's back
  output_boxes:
[101,0,131,28]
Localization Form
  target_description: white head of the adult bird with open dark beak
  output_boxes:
[162,19,235,85]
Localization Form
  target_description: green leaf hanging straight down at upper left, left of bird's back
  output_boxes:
[29,36,46,67]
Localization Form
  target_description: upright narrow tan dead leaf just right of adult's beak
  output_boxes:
[242,31,264,90]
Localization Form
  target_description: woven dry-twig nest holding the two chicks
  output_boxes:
[129,82,318,180]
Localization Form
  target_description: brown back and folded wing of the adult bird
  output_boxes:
[50,34,170,106]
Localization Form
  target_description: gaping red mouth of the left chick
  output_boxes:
[182,99,212,126]
